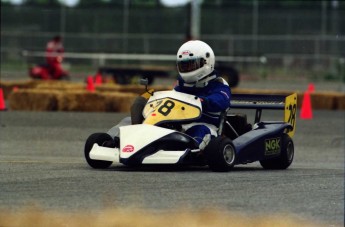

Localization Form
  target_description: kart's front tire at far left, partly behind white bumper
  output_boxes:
[84,133,113,169]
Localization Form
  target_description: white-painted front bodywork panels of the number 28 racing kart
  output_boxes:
[90,91,202,164]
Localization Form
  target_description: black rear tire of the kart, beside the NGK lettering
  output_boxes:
[260,134,295,169]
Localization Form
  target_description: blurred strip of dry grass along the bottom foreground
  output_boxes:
[0,208,322,227]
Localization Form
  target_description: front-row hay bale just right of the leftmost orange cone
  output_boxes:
[9,89,58,111]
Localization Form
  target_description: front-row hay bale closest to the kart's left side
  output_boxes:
[103,92,138,113]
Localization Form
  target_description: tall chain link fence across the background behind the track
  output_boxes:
[1,5,345,80]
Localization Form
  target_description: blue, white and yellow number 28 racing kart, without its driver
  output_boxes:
[84,81,297,172]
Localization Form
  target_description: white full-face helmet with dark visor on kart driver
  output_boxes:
[177,40,215,84]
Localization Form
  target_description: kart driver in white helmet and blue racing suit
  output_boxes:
[174,40,231,150]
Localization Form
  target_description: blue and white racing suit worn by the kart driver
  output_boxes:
[174,72,231,149]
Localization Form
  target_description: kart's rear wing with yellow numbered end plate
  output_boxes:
[230,93,297,137]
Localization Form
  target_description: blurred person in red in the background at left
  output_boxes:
[43,35,67,79]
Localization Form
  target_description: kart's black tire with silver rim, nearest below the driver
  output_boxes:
[204,137,236,172]
